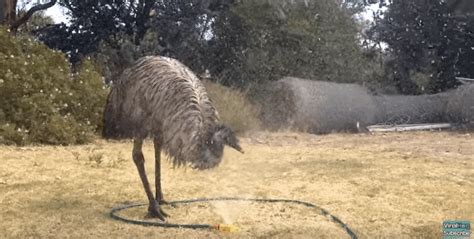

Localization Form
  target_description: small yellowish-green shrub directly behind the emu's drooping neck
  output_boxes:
[204,80,260,133]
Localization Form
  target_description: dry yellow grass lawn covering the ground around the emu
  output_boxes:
[0,132,474,238]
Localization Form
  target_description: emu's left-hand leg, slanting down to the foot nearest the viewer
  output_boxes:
[133,139,165,221]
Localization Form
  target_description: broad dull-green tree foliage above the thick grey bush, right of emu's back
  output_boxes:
[211,0,368,84]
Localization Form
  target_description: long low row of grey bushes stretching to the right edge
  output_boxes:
[253,77,474,133]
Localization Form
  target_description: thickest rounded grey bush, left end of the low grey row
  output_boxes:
[261,77,376,133]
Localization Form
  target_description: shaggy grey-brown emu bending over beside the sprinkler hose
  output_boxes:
[103,56,243,221]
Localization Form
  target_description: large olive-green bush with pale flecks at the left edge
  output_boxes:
[0,29,106,145]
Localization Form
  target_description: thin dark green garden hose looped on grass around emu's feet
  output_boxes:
[110,197,357,239]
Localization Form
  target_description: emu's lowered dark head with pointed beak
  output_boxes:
[195,125,244,169]
